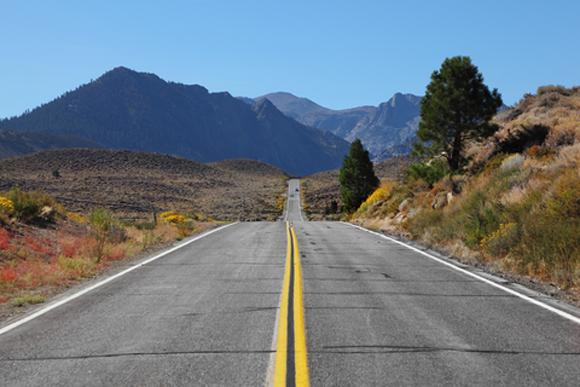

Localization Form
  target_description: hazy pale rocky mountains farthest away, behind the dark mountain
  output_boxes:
[251,92,421,160]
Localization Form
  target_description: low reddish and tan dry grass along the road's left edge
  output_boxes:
[0,191,215,317]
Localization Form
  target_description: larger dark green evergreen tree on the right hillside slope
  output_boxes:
[414,56,502,172]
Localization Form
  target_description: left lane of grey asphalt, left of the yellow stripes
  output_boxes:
[0,222,287,386]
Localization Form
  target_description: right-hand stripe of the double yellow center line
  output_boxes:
[290,228,310,387]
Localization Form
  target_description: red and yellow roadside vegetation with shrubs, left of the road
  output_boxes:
[0,188,215,316]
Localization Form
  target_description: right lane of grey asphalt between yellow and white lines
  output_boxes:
[296,222,580,386]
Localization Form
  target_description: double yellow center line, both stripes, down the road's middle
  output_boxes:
[274,222,310,387]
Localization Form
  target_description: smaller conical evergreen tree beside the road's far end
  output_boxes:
[339,139,379,212]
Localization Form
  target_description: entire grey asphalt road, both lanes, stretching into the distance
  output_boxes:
[0,180,580,386]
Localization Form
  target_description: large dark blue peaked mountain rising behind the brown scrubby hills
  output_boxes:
[0,67,348,175]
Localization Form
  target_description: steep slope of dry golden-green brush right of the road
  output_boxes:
[352,86,580,301]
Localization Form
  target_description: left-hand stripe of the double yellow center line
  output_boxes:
[274,222,292,387]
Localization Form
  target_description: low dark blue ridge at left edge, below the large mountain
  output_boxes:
[0,130,98,159]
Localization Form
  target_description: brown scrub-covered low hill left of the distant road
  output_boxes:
[0,149,286,220]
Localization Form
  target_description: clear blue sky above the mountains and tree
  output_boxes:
[0,0,580,117]
